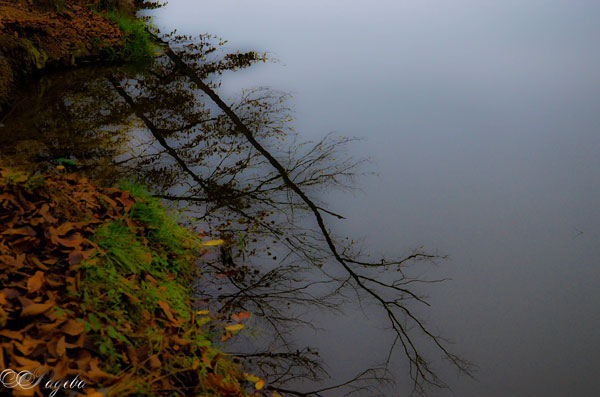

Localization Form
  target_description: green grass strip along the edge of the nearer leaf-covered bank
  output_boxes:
[80,184,248,396]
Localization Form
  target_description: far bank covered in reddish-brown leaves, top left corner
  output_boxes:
[0,0,134,114]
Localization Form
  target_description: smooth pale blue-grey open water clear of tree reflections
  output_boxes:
[146,0,600,396]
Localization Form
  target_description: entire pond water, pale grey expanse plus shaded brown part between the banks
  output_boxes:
[0,0,600,396]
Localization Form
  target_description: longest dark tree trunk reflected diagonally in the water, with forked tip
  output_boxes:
[157,36,476,391]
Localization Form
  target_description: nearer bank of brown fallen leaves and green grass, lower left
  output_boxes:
[0,167,263,396]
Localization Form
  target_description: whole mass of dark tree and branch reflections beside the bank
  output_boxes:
[0,34,469,396]
